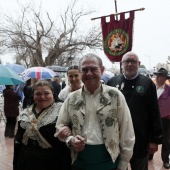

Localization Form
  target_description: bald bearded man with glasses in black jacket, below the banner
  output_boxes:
[107,51,162,170]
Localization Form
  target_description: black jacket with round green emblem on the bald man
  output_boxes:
[107,74,162,158]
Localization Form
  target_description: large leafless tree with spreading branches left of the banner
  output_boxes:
[0,0,102,67]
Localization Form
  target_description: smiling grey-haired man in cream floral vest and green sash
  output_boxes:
[56,53,135,170]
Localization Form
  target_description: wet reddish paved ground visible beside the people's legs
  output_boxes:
[0,120,165,170]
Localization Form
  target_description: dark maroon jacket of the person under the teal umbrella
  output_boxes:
[3,89,21,117]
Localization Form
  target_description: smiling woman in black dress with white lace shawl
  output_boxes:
[13,80,71,170]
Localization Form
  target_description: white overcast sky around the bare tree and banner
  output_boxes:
[0,0,170,69]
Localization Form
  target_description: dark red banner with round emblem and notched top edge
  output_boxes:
[101,11,134,62]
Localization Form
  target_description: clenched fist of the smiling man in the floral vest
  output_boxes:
[70,135,85,152]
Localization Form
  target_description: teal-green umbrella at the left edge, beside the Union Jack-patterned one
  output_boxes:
[0,64,25,85]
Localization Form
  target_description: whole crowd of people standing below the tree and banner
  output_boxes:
[3,51,170,170]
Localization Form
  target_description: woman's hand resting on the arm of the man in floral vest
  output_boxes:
[54,126,71,141]
